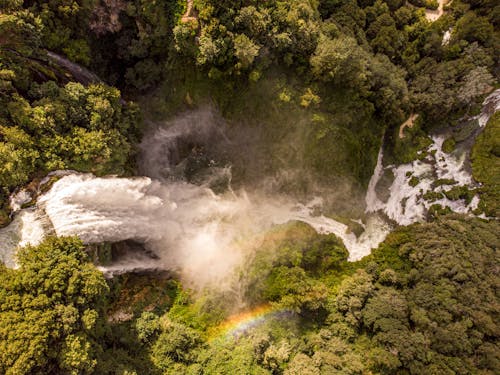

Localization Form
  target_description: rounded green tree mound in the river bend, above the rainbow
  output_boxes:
[244,223,348,314]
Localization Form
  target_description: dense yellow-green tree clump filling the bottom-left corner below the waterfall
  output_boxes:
[0,238,109,374]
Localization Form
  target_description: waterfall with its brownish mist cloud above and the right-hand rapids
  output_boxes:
[0,97,490,290]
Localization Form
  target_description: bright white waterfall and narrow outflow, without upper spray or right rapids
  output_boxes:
[0,173,389,284]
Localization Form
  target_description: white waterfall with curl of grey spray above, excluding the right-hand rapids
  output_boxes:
[0,110,389,285]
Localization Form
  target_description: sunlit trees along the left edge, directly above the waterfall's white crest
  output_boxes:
[0,11,140,217]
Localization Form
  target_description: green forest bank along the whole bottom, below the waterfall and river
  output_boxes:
[0,215,500,374]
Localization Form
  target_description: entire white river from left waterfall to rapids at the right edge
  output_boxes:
[0,90,500,283]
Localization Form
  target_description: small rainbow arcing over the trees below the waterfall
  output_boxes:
[210,304,288,340]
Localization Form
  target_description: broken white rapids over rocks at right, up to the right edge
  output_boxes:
[366,90,500,225]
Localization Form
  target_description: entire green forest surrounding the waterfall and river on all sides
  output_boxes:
[0,0,500,375]
